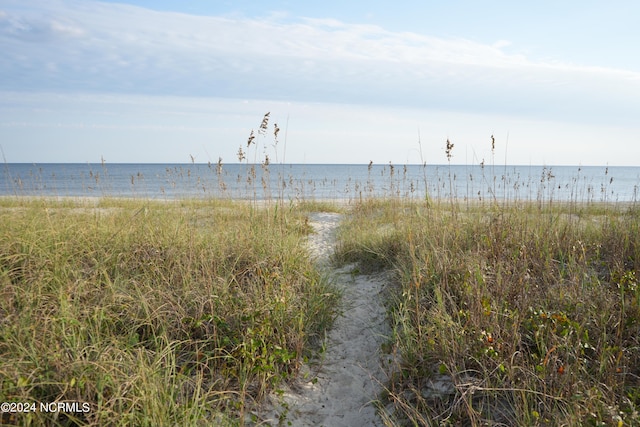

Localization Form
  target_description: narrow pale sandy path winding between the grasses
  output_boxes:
[252,213,390,427]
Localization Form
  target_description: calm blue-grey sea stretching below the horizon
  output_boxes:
[0,163,640,202]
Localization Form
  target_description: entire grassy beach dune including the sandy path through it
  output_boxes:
[0,197,640,426]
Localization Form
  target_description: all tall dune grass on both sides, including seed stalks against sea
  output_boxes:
[0,122,640,426]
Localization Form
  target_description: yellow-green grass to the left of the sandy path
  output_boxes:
[0,199,339,426]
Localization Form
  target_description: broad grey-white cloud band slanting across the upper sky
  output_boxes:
[0,0,640,129]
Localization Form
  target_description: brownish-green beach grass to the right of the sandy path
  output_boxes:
[334,199,640,426]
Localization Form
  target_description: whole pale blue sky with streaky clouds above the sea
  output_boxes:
[0,0,640,166]
